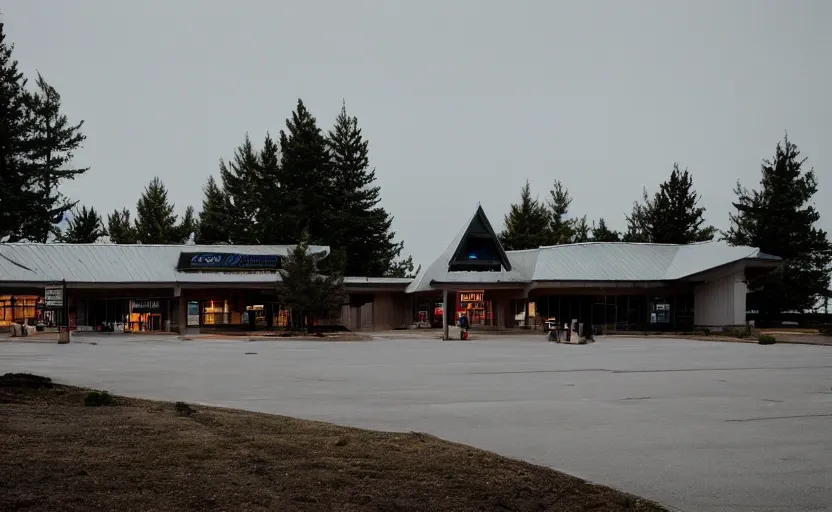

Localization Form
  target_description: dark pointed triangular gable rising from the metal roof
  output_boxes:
[448,206,511,272]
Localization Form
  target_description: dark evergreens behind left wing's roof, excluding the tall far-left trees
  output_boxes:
[95,100,414,276]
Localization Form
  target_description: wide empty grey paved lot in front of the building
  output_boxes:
[0,336,832,511]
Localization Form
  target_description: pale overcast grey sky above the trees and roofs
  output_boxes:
[2,0,832,264]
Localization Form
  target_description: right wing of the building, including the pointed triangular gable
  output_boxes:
[407,204,781,332]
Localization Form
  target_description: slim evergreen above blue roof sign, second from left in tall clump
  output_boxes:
[220,134,261,244]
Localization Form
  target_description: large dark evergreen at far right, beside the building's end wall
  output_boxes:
[723,136,832,320]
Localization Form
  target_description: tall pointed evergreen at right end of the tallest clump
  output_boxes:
[326,101,404,276]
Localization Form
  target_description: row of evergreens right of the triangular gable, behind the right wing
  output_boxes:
[500,136,832,320]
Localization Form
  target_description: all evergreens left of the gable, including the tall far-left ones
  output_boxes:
[0,23,414,276]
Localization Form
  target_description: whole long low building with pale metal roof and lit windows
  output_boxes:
[0,207,780,333]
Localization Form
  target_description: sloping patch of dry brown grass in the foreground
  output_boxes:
[0,375,663,512]
